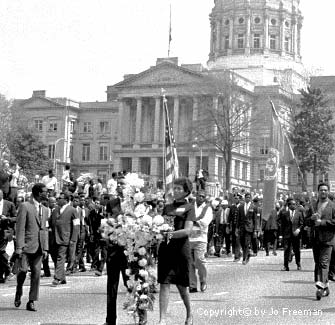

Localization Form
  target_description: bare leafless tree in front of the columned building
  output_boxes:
[193,71,253,190]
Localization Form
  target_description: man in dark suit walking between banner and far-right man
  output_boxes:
[278,198,304,271]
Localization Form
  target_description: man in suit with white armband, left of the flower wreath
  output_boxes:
[51,193,80,286]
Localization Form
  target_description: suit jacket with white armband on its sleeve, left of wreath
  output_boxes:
[51,205,80,246]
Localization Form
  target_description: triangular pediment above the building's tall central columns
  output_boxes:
[114,63,205,88]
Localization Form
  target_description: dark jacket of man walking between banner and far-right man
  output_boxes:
[278,209,304,238]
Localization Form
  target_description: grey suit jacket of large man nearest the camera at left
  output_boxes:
[16,199,49,254]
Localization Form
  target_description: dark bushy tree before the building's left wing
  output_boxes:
[7,122,52,179]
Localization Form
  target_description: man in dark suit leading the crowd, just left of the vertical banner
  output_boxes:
[237,193,257,265]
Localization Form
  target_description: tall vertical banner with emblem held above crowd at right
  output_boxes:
[262,148,279,220]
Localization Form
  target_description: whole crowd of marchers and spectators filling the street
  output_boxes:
[0,166,335,325]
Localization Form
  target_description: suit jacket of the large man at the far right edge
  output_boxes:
[305,200,335,245]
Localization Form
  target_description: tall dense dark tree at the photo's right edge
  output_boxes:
[290,87,335,191]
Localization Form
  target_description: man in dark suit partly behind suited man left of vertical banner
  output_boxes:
[228,194,241,262]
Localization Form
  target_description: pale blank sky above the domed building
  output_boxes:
[0,0,335,102]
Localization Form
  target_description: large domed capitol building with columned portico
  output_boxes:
[17,0,330,191]
